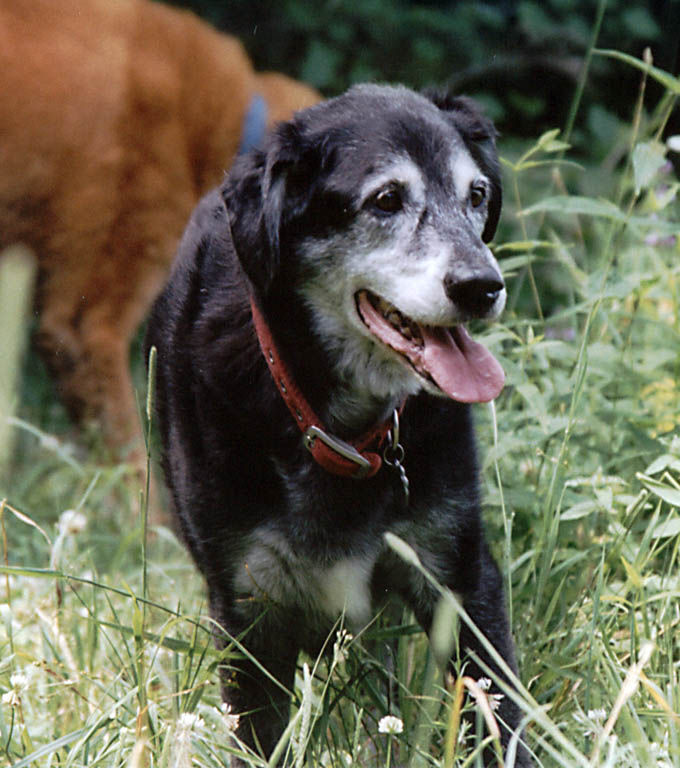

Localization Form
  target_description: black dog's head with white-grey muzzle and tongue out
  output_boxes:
[223,85,505,402]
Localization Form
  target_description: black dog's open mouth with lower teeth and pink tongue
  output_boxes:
[355,290,505,403]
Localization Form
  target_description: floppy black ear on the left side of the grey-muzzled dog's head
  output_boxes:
[222,121,319,295]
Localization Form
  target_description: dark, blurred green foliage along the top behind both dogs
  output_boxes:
[171,0,680,153]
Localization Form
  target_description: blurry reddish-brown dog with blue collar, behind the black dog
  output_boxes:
[0,0,320,453]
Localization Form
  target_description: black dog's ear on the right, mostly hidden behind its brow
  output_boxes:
[423,88,503,243]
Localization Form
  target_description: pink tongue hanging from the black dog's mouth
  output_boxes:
[420,325,505,403]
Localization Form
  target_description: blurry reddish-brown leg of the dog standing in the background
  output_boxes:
[37,252,174,467]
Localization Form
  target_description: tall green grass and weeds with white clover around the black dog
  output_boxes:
[0,51,680,768]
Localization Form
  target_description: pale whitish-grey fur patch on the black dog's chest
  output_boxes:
[235,530,377,628]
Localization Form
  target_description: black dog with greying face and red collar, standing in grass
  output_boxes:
[147,86,528,765]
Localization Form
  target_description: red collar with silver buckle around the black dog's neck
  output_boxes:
[250,297,393,479]
